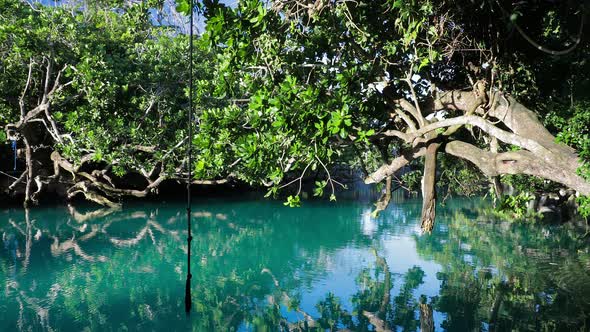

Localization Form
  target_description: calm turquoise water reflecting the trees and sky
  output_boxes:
[0,200,590,331]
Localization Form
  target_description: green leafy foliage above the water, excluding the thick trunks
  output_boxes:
[0,0,590,218]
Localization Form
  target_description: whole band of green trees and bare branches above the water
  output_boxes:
[0,0,590,230]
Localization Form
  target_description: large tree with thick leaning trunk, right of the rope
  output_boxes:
[185,0,590,230]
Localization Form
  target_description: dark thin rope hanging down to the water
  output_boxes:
[184,0,194,314]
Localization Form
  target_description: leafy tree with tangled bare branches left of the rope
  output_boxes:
[0,1,227,206]
